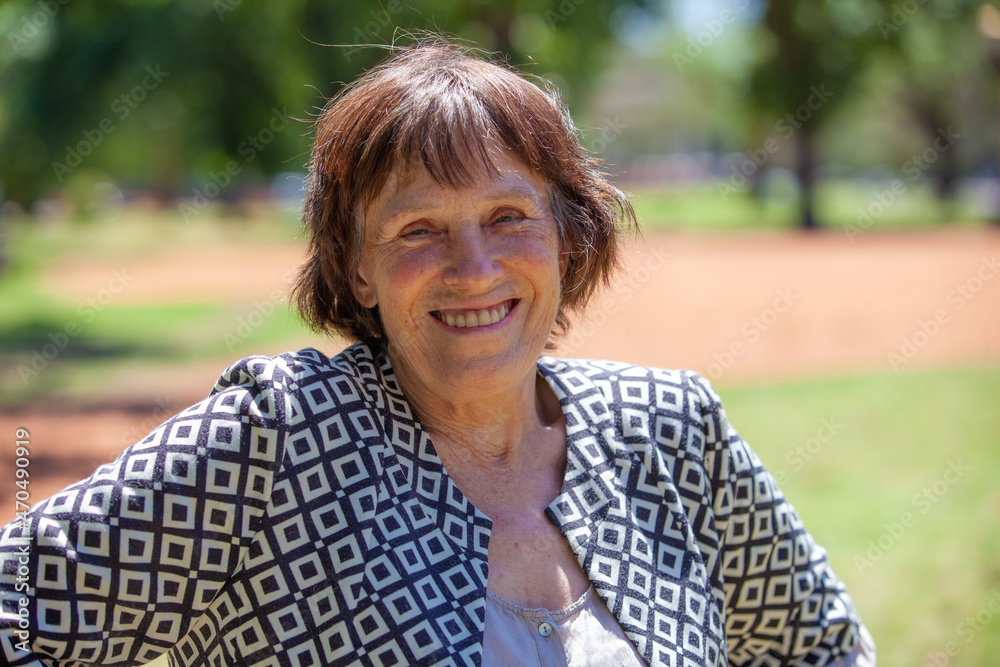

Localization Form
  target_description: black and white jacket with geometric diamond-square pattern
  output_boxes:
[0,344,860,667]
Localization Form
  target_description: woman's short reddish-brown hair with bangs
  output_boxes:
[292,40,636,340]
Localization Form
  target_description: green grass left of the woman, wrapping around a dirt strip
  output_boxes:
[0,213,306,405]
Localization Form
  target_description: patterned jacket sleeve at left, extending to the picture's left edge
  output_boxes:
[0,357,295,666]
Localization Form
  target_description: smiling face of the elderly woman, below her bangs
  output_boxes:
[354,153,562,401]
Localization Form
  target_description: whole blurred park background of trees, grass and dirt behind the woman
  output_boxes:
[0,0,1000,666]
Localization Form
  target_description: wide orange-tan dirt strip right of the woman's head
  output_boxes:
[564,230,1000,383]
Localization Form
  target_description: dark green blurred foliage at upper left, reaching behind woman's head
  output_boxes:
[0,0,656,211]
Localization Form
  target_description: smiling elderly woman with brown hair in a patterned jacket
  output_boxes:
[0,44,873,667]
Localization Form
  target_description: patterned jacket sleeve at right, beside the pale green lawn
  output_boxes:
[692,376,874,666]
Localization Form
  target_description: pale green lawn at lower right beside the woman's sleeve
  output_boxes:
[720,368,1000,665]
